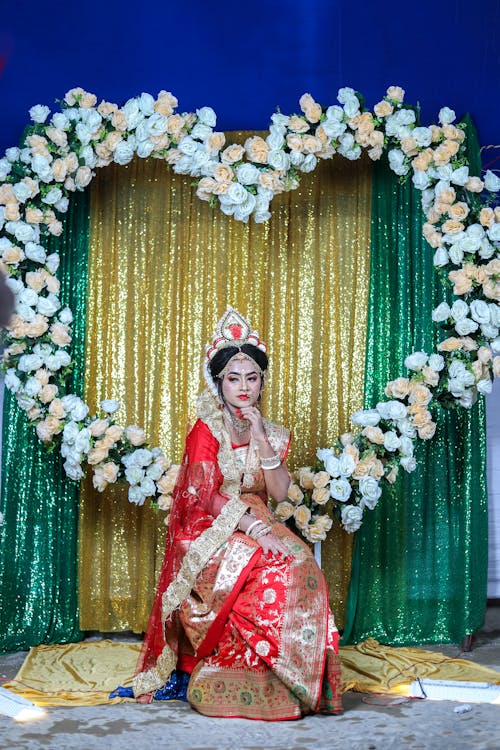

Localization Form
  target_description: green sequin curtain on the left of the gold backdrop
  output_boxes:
[0,192,89,652]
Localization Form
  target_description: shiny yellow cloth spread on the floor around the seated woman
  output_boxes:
[4,639,500,706]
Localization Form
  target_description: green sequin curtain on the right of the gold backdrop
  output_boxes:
[344,120,488,645]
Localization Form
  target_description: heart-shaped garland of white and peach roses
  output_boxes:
[0,86,500,541]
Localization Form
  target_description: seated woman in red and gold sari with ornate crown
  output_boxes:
[134,308,341,721]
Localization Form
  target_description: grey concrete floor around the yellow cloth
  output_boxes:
[0,606,500,750]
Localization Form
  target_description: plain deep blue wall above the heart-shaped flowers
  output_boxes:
[0,0,500,166]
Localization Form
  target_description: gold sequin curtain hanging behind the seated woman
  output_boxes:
[79,140,371,631]
